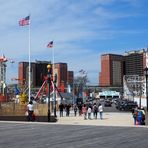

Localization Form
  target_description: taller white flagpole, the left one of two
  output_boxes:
[28,16,31,101]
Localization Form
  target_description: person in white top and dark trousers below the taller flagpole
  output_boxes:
[27,101,35,121]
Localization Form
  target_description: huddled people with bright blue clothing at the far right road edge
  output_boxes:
[132,107,145,125]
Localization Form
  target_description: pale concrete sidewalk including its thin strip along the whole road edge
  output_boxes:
[0,112,148,128]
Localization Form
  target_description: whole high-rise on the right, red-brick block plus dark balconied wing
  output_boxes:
[99,49,146,87]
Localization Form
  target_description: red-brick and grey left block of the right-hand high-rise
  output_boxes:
[99,54,123,86]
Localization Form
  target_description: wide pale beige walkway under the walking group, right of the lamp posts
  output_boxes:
[56,112,145,127]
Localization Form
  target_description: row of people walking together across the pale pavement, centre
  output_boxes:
[59,103,103,119]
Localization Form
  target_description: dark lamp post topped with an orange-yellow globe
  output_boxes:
[47,64,52,122]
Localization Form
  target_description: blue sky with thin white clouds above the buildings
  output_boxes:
[0,0,148,84]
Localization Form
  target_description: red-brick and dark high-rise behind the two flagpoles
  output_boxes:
[18,61,73,91]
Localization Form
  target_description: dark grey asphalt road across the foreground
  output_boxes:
[0,122,148,148]
